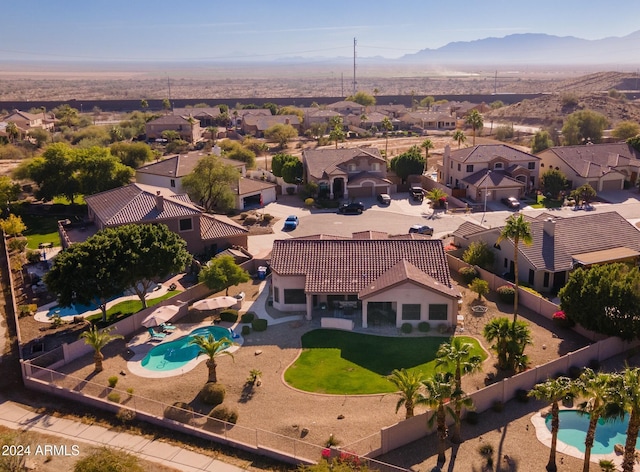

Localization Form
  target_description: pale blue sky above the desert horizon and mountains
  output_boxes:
[5,0,640,62]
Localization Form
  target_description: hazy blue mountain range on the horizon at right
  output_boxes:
[398,31,640,66]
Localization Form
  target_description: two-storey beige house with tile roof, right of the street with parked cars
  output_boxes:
[439,144,540,202]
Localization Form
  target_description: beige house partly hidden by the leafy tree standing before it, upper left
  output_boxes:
[136,152,276,210]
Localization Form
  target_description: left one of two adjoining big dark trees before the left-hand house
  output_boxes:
[44,232,128,322]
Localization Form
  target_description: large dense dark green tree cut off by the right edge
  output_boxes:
[558,263,640,340]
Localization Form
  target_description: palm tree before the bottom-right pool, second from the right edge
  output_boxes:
[578,368,613,472]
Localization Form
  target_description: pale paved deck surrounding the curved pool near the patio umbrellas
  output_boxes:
[127,322,244,379]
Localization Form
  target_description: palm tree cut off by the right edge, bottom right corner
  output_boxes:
[616,367,640,472]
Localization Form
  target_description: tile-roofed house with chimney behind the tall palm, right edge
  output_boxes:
[453,212,640,293]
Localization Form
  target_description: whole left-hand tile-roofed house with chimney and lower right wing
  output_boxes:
[85,183,248,254]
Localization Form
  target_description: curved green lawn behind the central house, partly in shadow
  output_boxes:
[284,329,487,395]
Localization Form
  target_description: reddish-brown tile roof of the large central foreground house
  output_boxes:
[271,239,452,293]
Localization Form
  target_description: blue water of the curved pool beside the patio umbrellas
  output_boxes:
[142,326,232,372]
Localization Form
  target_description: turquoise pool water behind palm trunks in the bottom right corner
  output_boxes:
[545,410,640,454]
